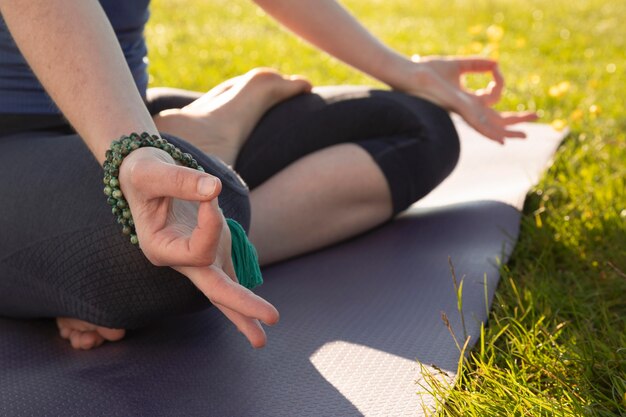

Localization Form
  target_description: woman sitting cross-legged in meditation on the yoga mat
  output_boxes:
[0,0,535,349]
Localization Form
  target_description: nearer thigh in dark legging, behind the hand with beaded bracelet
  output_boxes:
[0,128,249,328]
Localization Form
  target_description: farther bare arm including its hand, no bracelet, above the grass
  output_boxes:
[254,0,536,143]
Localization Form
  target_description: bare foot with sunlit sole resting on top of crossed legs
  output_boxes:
[154,68,311,165]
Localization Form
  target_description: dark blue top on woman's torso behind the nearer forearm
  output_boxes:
[0,0,150,114]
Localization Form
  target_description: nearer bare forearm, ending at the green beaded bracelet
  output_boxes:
[0,0,157,162]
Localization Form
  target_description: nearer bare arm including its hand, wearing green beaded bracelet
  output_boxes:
[0,0,278,346]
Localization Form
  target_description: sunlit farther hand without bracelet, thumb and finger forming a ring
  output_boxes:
[396,57,537,144]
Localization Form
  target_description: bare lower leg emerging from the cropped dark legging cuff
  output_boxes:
[250,144,392,265]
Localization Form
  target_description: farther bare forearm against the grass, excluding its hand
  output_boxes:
[254,0,410,87]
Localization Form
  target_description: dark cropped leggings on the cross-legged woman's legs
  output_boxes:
[0,87,459,328]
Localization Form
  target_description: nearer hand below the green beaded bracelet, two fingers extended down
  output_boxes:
[119,148,278,347]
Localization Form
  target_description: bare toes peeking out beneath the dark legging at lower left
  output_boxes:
[57,317,126,350]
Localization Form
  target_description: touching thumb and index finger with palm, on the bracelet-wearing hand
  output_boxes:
[120,149,224,266]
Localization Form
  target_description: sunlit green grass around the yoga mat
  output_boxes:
[147,0,626,416]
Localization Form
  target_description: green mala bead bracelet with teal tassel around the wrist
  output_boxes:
[103,132,263,289]
